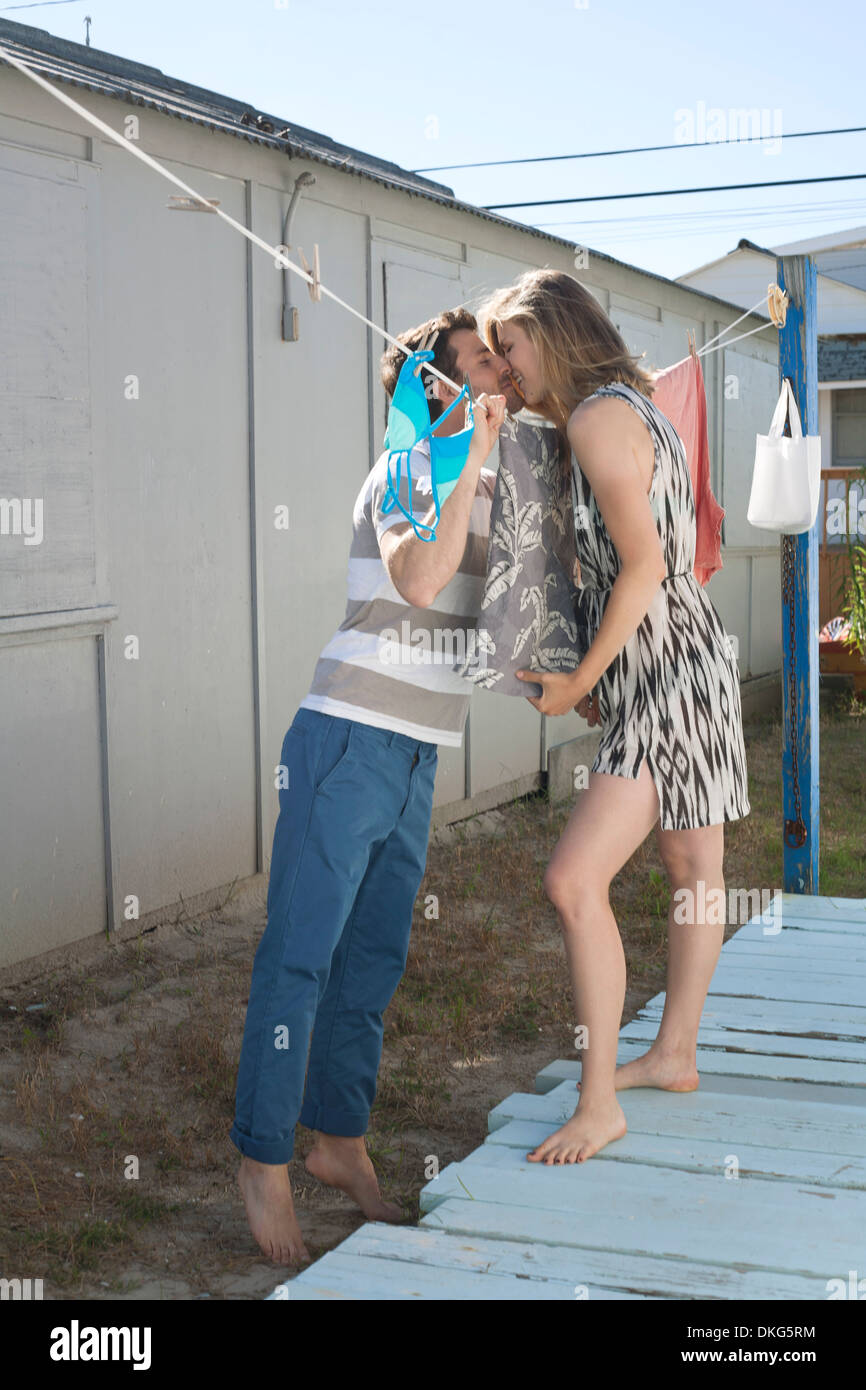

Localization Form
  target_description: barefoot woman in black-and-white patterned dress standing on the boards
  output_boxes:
[482,270,749,1163]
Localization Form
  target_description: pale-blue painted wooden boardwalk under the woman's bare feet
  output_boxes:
[270,894,866,1301]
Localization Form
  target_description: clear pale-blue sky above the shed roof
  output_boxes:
[6,0,866,277]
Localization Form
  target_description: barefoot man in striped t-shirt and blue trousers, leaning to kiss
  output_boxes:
[231,309,523,1264]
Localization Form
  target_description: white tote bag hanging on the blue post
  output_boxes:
[748,378,822,535]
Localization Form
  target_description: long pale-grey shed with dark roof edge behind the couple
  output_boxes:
[0,19,781,966]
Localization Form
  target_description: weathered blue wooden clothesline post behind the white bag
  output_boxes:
[776,256,822,894]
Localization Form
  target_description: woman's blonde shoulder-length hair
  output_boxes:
[478,268,653,442]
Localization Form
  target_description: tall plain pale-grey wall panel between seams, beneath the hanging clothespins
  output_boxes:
[101,147,254,913]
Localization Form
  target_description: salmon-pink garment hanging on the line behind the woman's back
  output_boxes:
[652,354,724,584]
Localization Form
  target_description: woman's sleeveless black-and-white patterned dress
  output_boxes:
[571,382,751,830]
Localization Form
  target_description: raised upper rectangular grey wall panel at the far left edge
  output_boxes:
[0,147,96,616]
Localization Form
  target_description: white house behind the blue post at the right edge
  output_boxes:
[677,227,866,627]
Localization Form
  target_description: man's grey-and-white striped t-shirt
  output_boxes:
[300,439,496,748]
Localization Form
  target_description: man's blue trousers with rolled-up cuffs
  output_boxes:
[231,708,436,1163]
